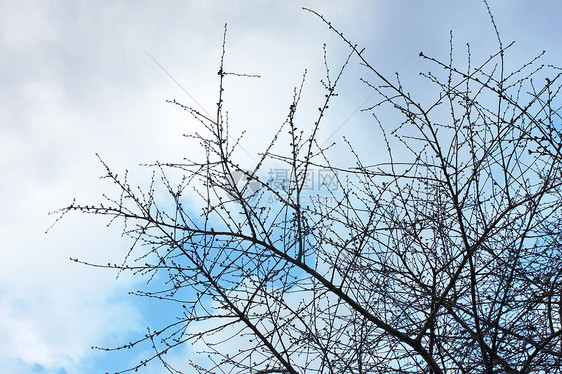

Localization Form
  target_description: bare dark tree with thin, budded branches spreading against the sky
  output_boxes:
[53,5,562,373]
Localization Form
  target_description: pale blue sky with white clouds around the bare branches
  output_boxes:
[0,0,562,374]
